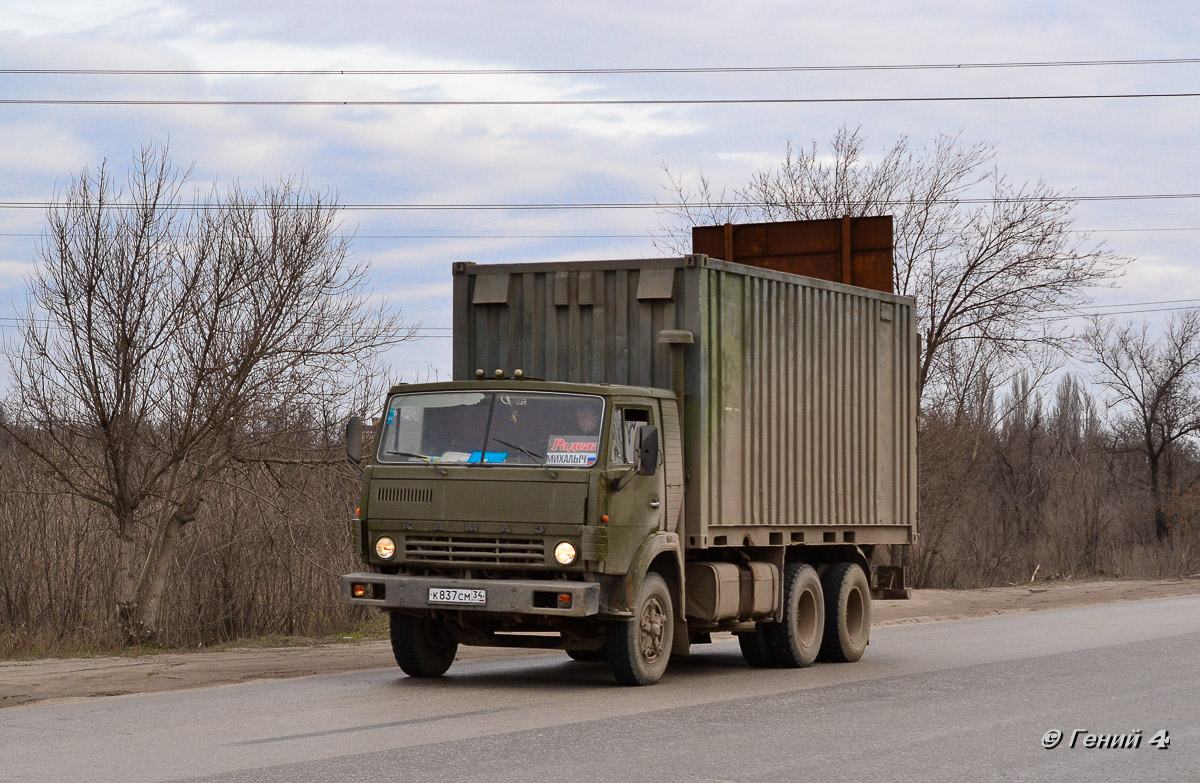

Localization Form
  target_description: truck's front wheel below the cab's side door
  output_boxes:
[607,572,674,686]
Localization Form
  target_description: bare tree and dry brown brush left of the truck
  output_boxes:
[0,147,403,651]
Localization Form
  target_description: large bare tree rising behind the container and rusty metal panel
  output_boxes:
[665,126,1124,399]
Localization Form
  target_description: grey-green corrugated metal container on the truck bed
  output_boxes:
[454,255,917,548]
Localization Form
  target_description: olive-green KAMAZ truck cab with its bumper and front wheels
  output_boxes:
[342,379,683,681]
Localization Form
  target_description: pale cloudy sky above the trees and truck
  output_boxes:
[0,0,1200,379]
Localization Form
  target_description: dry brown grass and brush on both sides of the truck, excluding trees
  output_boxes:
[0,403,1200,658]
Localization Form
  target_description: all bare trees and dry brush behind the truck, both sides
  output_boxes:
[0,137,1200,657]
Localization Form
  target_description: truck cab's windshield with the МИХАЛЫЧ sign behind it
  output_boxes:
[379,392,604,467]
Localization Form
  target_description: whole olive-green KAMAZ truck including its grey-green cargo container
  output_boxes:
[341,217,917,685]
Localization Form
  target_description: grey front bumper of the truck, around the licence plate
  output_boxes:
[342,573,600,617]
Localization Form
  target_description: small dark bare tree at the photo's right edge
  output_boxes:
[1080,310,1200,540]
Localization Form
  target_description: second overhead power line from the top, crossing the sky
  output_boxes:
[7,92,1200,107]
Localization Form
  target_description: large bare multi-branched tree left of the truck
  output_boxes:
[0,147,412,642]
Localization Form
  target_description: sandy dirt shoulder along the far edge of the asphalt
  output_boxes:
[0,579,1200,707]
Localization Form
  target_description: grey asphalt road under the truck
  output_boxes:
[0,597,1200,783]
